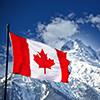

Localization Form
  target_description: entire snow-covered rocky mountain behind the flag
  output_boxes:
[0,39,100,100]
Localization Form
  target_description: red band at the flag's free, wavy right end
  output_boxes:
[56,49,70,83]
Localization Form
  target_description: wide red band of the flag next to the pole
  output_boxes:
[10,32,31,77]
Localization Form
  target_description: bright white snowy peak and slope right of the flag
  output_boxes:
[61,39,100,100]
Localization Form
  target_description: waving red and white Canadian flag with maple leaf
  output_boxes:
[10,32,70,83]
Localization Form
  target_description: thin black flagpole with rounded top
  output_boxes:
[4,23,10,100]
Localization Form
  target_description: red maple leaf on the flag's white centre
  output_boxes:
[33,49,55,74]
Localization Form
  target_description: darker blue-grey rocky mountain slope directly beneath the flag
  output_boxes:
[0,75,75,100]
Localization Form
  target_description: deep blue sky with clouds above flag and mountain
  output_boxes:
[0,0,100,75]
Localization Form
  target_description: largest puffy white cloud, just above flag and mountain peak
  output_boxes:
[37,17,79,48]
